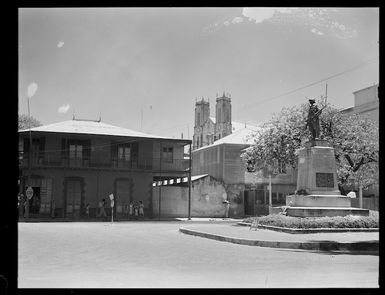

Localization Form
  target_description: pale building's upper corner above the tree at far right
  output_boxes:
[340,84,379,123]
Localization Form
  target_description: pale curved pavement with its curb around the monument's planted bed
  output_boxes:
[179,222,379,252]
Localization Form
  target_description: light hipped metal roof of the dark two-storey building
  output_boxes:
[19,120,190,142]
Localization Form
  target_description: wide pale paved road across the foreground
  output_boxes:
[18,222,379,288]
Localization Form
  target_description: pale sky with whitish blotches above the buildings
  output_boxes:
[18,7,379,139]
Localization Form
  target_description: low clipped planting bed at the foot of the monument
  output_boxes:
[243,211,379,229]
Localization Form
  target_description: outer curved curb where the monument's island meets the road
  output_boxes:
[179,227,379,251]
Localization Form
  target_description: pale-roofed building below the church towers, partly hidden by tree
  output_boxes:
[192,125,297,217]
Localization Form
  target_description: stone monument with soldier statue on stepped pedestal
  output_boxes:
[286,99,369,217]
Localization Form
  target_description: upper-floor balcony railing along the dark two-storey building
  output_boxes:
[19,152,188,171]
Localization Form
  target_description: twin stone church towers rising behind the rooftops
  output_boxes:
[193,93,232,150]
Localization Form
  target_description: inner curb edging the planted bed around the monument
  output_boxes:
[237,222,379,234]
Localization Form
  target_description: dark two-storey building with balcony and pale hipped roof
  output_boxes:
[19,120,191,220]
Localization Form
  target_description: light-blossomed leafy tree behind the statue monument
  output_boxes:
[241,102,379,192]
